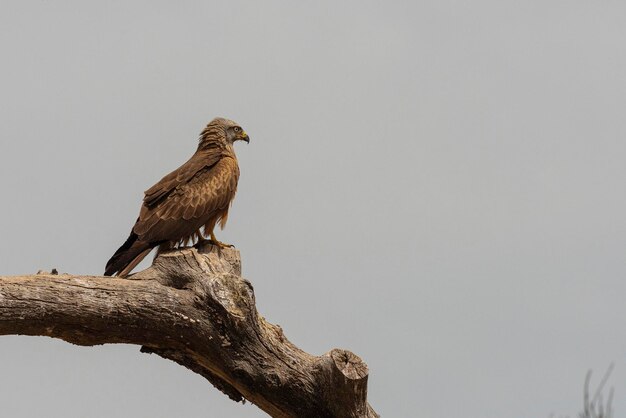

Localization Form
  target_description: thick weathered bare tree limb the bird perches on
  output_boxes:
[0,245,378,418]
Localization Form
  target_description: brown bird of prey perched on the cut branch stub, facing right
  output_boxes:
[104,118,250,277]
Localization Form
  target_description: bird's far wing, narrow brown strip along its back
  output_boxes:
[143,148,221,208]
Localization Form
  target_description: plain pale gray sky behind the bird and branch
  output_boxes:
[0,0,626,418]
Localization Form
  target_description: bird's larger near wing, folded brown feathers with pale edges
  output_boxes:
[133,157,239,242]
